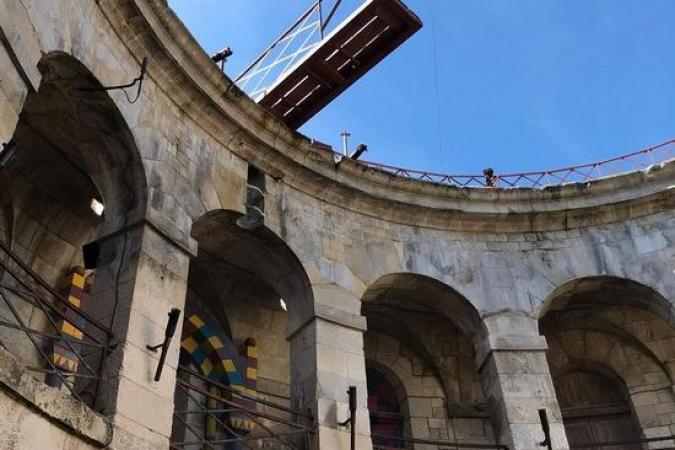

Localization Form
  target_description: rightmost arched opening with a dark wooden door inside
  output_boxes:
[539,277,675,450]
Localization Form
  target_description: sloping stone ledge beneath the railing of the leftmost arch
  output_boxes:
[0,348,112,447]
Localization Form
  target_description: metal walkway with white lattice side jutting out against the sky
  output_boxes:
[235,0,422,129]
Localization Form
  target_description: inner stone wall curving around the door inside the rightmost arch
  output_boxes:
[546,307,675,448]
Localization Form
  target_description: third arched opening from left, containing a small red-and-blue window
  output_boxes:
[362,273,495,448]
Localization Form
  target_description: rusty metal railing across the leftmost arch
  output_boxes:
[0,240,114,409]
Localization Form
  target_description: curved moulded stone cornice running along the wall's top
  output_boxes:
[97,0,675,233]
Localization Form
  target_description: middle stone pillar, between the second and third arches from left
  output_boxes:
[289,298,372,450]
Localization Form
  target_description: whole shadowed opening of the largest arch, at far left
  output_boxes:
[0,51,147,410]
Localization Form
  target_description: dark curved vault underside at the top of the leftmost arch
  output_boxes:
[10,51,147,233]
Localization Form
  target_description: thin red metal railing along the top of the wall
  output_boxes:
[344,139,675,188]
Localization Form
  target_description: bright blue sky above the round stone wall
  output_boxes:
[169,0,675,174]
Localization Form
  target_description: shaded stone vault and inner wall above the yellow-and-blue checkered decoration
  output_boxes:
[182,210,314,422]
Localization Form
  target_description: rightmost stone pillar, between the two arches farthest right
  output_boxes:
[476,312,569,450]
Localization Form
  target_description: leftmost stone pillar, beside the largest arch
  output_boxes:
[91,222,191,450]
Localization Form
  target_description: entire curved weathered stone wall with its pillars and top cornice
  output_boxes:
[0,0,675,450]
